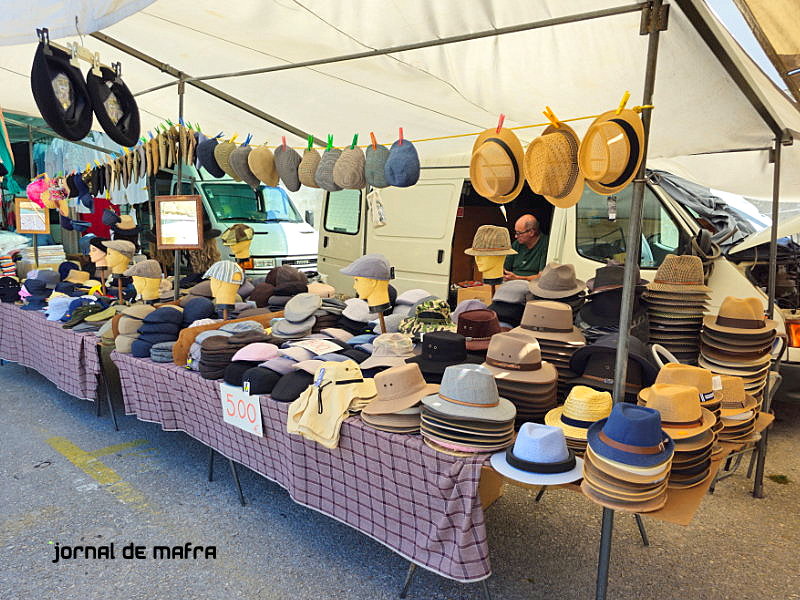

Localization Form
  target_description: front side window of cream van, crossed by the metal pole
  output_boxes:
[575,184,684,269]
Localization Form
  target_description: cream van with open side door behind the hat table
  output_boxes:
[318,167,800,396]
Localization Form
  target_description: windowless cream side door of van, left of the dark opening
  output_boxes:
[366,177,464,298]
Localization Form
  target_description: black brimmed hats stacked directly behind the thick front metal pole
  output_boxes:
[569,333,658,404]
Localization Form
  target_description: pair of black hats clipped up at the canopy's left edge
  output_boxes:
[31,28,140,146]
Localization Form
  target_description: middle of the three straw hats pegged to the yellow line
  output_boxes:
[523,123,583,208]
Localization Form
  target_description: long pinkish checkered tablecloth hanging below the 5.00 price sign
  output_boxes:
[112,352,491,582]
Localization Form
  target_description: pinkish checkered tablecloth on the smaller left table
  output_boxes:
[0,302,100,400]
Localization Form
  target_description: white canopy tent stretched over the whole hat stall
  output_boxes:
[0,0,800,201]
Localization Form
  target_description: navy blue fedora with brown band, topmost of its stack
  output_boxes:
[587,402,675,467]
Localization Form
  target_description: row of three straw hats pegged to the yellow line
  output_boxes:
[469,94,644,208]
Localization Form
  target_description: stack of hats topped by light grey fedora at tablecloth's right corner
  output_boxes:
[420,365,516,454]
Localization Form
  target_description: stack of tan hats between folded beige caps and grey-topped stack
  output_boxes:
[361,364,439,433]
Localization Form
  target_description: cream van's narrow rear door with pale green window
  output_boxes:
[317,190,365,293]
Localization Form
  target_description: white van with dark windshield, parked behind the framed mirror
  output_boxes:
[161,167,319,275]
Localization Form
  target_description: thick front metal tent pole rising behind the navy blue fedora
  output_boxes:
[595,0,669,600]
